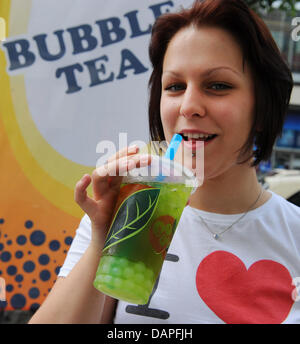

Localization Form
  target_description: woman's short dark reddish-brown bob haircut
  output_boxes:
[148,0,293,166]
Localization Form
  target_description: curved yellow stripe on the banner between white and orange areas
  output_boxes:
[0,0,91,218]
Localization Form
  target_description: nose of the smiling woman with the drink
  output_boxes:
[180,86,206,118]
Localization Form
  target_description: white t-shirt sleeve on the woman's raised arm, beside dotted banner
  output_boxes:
[58,215,91,277]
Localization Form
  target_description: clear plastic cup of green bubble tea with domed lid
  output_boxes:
[94,156,197,304]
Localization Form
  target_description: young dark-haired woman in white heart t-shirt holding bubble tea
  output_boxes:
[31,0,300,323]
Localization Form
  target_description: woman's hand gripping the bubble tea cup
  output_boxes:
[75,146,151,249]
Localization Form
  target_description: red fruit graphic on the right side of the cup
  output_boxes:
[149,215,175,253]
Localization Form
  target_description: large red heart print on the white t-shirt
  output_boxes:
[196,251,294,324]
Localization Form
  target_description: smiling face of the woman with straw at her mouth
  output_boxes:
[160,27,255,179]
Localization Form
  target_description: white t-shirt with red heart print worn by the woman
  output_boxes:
[59,193,300,324]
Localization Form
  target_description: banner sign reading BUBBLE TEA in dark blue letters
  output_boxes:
[0,0,192,310]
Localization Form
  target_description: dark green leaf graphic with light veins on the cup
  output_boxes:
[103,188,160,251]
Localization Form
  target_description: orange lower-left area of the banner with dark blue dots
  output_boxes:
[0,111,79,310]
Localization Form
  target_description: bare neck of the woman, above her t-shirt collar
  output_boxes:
[189,166,268,214]
